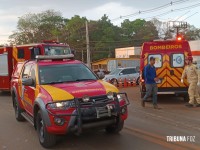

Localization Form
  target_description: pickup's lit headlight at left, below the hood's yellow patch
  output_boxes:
[48,101,73,109]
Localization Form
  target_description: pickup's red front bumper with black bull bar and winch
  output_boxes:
[46,93,130,134]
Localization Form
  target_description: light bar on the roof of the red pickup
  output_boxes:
[36,54,74,60]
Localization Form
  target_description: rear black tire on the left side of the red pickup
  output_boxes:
[13,95,25,122]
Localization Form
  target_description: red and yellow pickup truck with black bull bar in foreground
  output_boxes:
[11,55,129,148]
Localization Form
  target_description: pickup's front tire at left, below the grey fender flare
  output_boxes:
[36,111,56,148]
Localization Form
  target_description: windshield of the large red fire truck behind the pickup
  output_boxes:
[45,46,71,55]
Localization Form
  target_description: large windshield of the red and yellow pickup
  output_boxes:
[39,64,97,84]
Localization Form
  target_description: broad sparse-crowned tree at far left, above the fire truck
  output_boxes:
[9,10,66,44]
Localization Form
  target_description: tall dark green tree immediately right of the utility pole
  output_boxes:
[89,15,120,60]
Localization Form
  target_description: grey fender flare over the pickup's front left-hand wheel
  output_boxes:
[33,98,51,127]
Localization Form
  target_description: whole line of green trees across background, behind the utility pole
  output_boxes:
[9,10,200,61]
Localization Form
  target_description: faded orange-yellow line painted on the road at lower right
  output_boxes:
[124,126,199,150]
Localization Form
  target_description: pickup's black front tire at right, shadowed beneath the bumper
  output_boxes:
[106,121,124,134]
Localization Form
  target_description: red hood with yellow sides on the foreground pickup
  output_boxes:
[41,80,119,101]
